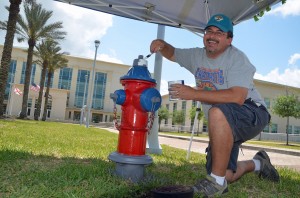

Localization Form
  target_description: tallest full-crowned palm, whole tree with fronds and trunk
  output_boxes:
[16,3,66,118]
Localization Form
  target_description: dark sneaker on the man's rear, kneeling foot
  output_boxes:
[253,150,280,182]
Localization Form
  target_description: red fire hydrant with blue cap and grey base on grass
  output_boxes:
[108,55,161,182]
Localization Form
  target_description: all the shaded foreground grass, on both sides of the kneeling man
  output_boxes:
[0,148,300,198]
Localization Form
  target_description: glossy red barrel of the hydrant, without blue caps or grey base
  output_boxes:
[118,80,156,155]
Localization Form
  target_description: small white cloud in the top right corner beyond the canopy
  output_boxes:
[268,0,300,17]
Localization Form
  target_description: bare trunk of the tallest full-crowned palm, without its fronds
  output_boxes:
[19,39,35,119]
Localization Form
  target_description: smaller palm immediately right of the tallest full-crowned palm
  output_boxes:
[33,39,61,120]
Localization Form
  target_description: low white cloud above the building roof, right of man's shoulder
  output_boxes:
[254,68,300,87]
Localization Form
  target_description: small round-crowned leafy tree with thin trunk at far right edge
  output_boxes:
[272,95,300,145]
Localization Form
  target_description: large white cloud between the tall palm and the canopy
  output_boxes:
[53,2,113,57]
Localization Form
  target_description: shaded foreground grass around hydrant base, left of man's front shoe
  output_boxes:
[0,150,201,198]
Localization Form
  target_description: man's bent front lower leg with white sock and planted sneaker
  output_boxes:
[195,107,233,197]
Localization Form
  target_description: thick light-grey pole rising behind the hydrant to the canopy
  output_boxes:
[147,25,165,154]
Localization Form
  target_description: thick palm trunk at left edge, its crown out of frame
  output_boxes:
[0,0,22,118]
